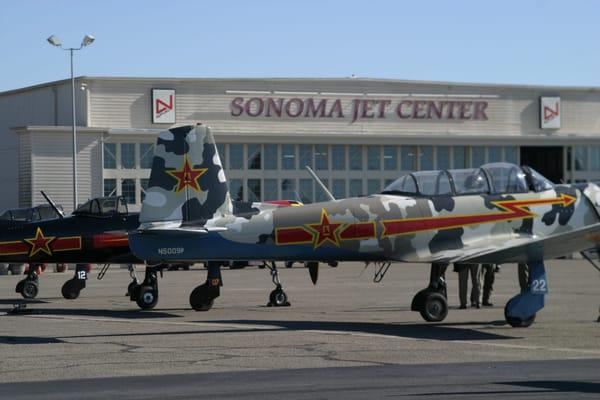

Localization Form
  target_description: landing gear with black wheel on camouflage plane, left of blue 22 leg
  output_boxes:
[410,263,448,322]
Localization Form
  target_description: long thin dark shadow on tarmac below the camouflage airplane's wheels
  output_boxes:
[202,319,515,341]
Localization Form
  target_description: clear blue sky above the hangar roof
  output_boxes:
[0,0,600,91]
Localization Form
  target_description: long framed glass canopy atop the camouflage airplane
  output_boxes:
[381,162,554,196]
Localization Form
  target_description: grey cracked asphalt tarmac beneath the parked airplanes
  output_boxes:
[0,260,600,399]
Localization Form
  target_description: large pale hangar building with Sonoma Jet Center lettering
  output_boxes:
[0,76,600,211]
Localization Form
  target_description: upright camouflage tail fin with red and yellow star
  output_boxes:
[140,125,233,225]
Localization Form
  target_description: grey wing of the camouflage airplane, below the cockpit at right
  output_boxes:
[434,223,600,264]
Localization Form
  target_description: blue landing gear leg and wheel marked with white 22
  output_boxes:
[504,261,548,328]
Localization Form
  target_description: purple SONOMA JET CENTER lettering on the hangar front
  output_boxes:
[229,97,488,123]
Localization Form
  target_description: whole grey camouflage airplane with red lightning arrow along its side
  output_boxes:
[129,125,600,326]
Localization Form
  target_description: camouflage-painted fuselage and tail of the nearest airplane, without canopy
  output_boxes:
[130,126,600,263]
